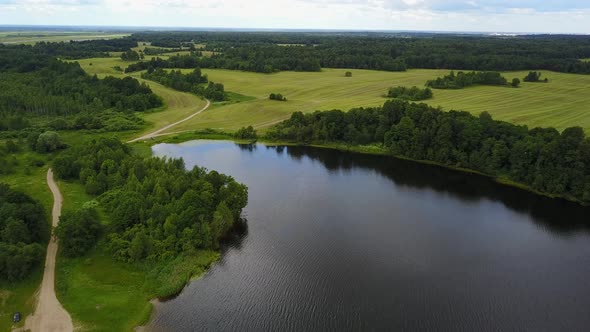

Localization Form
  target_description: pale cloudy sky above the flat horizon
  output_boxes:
[0,0,590,34]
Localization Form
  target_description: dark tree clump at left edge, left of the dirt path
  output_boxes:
[0,184,49,281]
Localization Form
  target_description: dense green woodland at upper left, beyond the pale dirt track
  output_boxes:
[0,45,162,131]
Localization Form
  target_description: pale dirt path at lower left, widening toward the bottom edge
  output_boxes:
[25,168,74,332]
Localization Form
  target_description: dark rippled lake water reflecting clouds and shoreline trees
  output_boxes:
[152,141,590,331]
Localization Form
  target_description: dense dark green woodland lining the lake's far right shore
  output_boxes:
[268,100,590,203]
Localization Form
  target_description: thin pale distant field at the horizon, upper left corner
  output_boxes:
[0,31,130,44]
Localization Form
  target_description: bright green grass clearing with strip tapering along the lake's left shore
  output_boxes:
[56,243,219,332]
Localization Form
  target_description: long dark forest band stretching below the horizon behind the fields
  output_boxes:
[122,32,590,74]
